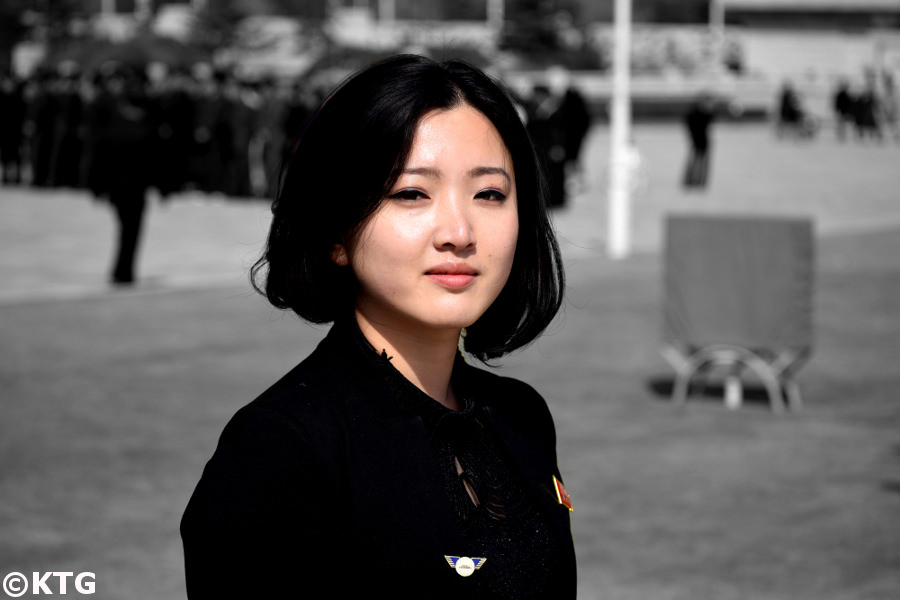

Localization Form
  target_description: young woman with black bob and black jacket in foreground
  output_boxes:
[182,56,576,599]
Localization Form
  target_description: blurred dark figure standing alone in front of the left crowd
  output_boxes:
[88,65,157,286]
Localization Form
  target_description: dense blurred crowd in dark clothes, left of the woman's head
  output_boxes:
[0,63,319,197]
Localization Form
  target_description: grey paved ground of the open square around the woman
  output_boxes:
[0,119,900,600]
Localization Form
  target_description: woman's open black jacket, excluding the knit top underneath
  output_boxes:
[181,323,576,600]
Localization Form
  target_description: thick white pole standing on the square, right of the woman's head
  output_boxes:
[607,0,631,259]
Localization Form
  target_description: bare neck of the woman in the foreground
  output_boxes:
[356,311,460,410]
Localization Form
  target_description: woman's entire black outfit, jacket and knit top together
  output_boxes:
[181,319,577,600]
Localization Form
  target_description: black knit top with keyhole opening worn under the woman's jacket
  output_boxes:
[357,330,563,599]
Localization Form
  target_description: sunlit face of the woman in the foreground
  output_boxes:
[333,104,519,332]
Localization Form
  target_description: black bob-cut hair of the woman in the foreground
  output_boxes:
[251,55,565,361]
